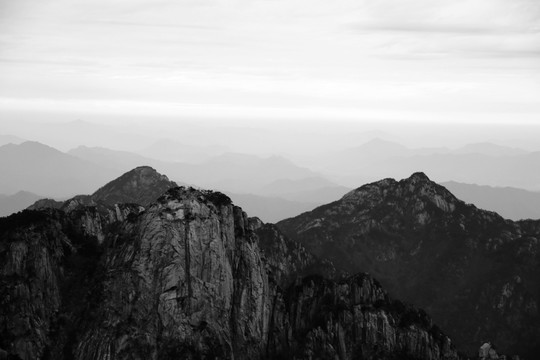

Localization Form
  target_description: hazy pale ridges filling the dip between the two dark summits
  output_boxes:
[69,146,350,222]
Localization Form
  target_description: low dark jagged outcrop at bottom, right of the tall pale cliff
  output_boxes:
[268,274,458,360]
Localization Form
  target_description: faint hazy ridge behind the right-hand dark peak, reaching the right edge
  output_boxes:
[316,139,540,191]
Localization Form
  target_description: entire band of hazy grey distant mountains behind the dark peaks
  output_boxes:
[0,136,540,222]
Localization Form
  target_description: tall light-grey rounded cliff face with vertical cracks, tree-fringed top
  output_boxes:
[71,188,271,359]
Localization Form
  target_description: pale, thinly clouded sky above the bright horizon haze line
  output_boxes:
[0,0,540,124]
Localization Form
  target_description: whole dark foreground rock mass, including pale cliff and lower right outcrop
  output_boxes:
[0,169,458,360]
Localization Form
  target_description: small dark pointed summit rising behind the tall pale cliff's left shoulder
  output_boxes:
[92,166,177,206]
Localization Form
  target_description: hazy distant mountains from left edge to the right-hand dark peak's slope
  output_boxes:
[0,142,349,221]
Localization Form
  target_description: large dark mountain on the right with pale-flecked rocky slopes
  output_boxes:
[277,173,540,358]
